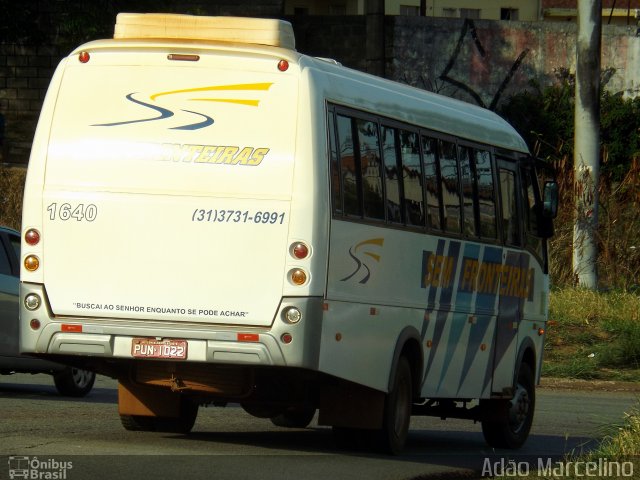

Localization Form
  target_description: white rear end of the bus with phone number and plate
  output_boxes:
[21,17,321,429]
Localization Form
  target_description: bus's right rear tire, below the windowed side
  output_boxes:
[377,356,413,455]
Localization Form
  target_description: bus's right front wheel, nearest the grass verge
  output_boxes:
[482,363,536,449]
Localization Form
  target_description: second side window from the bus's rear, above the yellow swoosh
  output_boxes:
[356,119,384,220]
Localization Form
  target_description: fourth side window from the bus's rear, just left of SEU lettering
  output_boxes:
[400,130,425,227]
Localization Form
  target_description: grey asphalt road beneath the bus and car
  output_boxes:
[0,375,638,480]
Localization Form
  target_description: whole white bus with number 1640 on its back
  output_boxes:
[21,14,555,453]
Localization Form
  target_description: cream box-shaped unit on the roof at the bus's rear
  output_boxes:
[113,13,296,50]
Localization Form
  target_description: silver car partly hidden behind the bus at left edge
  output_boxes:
[0,227,96,397]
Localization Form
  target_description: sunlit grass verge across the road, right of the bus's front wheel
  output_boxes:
[542,288,640,382]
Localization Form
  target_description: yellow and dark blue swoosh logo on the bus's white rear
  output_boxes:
[91,83,273,130]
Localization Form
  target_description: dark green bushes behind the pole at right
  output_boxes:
[499,74,640,290]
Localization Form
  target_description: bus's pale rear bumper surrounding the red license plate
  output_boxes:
[20,283,322,370]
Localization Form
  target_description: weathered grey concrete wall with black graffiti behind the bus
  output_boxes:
[385,17,640,108]
